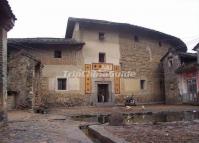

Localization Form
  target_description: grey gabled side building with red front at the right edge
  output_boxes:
[161,48,199,104]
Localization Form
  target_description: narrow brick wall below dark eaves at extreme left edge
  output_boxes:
[0,26,7,126]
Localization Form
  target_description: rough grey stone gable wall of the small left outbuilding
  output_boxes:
[8,51,37,108]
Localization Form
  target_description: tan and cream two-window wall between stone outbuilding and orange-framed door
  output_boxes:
[26,46,85,106]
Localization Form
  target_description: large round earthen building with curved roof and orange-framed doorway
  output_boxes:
[8,18,187,106]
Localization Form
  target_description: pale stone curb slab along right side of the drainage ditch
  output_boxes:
[88,125,129,143]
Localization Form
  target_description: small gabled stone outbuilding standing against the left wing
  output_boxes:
[7,43,42,110]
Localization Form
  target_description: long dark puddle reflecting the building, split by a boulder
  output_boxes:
[72,111,199,124]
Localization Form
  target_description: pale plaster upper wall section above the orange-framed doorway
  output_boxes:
[80,28,120,65]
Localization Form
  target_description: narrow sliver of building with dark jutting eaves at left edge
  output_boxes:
[0,0,16,126]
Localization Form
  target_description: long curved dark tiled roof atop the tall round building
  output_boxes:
[65,17,187,52]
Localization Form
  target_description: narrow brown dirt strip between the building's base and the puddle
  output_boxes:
[50,105,199,116]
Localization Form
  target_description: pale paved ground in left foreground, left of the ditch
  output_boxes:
[0,111,91,143]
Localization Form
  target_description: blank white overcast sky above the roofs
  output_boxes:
[8,0,199,51]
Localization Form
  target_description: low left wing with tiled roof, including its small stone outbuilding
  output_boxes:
[8,38,86,107]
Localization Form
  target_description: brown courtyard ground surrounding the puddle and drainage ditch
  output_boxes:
[0,105,199,143]
